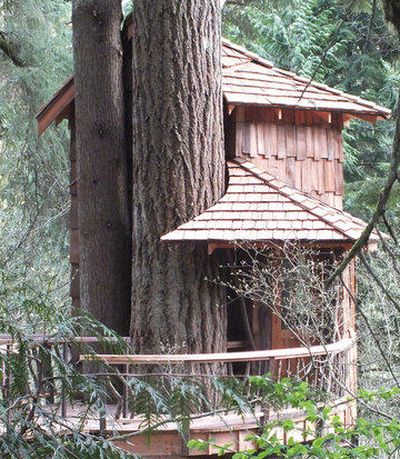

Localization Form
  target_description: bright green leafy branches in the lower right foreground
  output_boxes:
[188,377,400,459]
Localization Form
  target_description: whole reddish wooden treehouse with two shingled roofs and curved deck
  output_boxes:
[37,22,390,457]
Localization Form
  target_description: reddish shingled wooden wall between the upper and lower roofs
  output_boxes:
[231,107,343,209]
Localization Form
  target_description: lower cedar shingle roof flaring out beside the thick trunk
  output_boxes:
[161,159,378,246]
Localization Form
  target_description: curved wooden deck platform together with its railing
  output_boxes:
[0,336,356,458]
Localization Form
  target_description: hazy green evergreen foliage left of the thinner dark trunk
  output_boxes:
[0,0,72,316]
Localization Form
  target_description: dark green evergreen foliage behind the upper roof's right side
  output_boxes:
[224,0,400,219]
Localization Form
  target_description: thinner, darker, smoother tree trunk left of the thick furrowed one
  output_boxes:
[72,0,131,334]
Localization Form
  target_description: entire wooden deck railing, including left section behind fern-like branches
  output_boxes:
[0,335,355,430]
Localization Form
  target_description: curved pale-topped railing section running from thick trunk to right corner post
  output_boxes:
[80,339,356,418]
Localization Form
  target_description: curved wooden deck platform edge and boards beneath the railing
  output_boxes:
[61,399,355,458]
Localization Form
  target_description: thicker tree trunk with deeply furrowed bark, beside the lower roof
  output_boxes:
[131,0,226,353]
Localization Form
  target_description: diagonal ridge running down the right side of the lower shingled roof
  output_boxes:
[230,158,361,238]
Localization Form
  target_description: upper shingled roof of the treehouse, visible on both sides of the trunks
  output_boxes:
[36,39,390,134]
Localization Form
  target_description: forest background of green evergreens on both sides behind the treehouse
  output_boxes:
[0,0,400,434]
